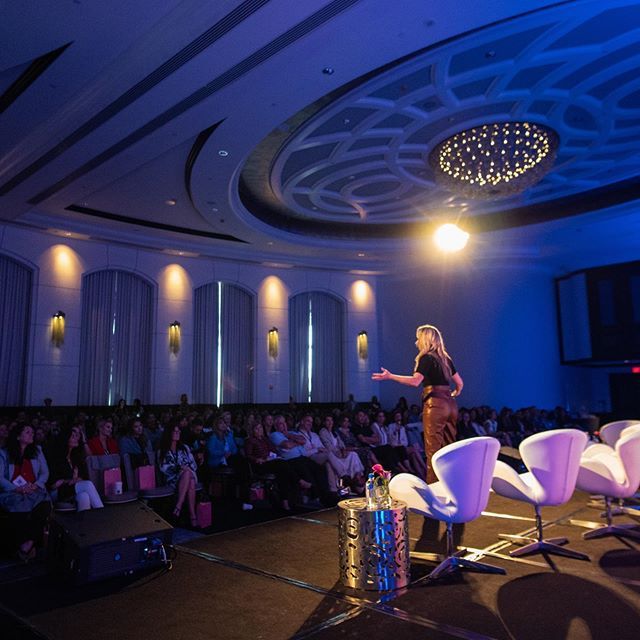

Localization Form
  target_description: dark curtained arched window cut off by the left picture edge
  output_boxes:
[0,255,33,407]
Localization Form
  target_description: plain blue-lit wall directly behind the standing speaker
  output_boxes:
[373,264,565,409]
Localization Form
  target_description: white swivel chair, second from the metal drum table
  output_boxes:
[491,429,589,560]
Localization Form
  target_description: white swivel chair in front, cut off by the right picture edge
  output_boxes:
[571,425,640,540]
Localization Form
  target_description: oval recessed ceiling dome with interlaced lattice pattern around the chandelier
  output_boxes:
[232,0,640,237]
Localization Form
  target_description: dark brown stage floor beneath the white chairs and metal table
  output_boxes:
[0,493,640,640]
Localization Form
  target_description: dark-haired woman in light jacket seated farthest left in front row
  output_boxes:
[0,424,51,561]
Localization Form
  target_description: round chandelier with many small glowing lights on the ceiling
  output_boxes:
[429,122,559,199]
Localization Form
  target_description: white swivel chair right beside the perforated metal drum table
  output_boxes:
[389,437,505,579]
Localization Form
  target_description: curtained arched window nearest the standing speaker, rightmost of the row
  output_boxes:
[289,291,344,402]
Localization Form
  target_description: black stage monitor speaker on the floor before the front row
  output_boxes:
[48,502,173,584]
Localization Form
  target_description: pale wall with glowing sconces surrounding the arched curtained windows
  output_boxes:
[0,226,378,405]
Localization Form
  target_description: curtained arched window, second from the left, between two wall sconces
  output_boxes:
[78,270,154,405]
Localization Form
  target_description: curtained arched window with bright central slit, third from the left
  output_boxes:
[193,282,255,406]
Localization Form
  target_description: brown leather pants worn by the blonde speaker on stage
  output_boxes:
[422,386,458,483]
